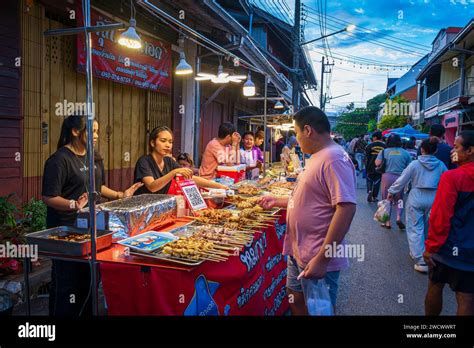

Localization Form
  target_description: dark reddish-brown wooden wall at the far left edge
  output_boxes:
[0,0,23,197]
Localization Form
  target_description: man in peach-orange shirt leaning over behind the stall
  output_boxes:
[199,123,240,179]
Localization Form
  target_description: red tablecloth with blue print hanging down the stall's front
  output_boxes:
[100,216,288,315]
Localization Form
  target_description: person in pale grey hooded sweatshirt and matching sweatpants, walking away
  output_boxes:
[388,138,448,273]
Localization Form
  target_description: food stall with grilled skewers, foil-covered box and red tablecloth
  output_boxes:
[24,172,293,315]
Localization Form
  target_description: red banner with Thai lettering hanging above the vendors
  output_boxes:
[77,8,171,93]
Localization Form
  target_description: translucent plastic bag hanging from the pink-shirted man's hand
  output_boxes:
[302,278,334,316]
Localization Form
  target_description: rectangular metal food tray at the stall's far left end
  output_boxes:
[26,226,113,256]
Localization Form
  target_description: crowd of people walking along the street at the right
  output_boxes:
[338,125,474,315]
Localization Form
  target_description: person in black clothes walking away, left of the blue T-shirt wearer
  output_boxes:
[365,131,385,202]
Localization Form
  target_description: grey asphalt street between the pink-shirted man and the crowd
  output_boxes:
[337,178,456,315]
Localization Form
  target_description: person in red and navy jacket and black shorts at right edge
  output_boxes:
[423,130,474,315]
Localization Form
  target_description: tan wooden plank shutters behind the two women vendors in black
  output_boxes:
[22,3,172,200]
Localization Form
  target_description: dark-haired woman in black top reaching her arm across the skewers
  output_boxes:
[134,126,227,194]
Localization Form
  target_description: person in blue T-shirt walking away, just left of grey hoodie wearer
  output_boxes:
[375,134,411,230]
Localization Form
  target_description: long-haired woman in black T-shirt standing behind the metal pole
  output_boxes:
[42,116,140,316]
